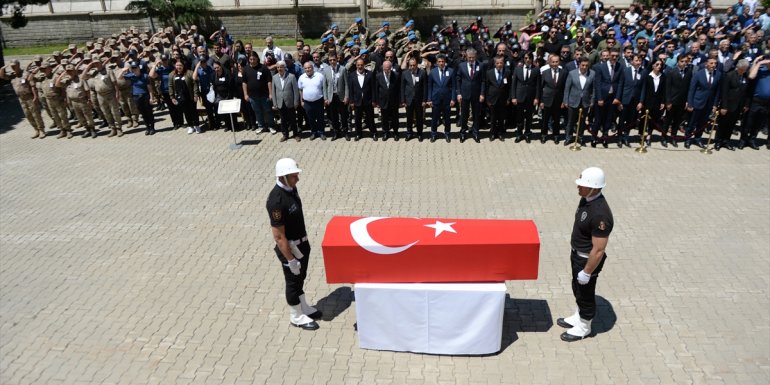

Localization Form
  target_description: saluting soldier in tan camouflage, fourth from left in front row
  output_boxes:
[82,55,123,137]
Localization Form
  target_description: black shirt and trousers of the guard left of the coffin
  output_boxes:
[267,184,310,306]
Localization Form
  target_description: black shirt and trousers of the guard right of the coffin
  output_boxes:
[570,195,613,320]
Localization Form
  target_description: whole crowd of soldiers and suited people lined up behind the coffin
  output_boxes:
[0,0,770,150]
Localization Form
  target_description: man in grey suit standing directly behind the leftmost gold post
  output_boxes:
[564,58,595,146]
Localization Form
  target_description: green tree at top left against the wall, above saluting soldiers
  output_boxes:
[126,0,211,29]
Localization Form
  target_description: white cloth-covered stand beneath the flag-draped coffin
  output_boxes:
[354,282,505,355]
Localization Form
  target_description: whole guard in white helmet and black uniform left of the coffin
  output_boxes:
[267,158,322,330]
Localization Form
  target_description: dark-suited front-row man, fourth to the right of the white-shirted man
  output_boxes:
[401,59,428,142]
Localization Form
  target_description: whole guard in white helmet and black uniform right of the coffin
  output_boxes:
[556,167,614,342]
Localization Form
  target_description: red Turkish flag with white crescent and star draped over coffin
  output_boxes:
[321,217,540,283]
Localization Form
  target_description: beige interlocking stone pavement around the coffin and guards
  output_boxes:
[0,87,770,385]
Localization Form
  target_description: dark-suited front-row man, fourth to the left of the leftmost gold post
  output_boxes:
[456,48,484,143]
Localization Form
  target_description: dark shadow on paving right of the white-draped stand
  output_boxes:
[495,294,553,354]
